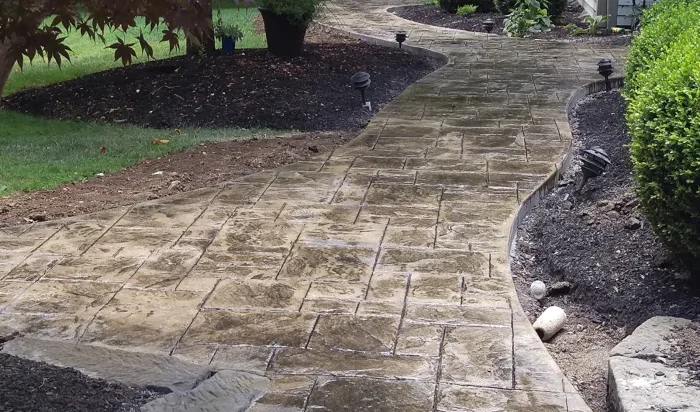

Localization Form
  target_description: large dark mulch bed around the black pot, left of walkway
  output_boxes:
[0,38,444,131]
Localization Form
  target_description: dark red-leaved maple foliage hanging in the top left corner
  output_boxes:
[0,0,213,96]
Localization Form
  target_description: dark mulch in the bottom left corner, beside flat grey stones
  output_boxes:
[0,354,155,412]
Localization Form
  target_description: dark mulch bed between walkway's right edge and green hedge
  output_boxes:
[512,92,700,412]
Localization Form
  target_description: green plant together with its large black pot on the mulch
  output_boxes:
[256,0,325,57]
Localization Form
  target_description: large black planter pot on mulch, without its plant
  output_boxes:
[260,9,309,57]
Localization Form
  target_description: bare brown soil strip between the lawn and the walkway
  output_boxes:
[0,132,355,227]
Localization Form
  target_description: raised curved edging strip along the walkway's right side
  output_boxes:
[508,77,624,256]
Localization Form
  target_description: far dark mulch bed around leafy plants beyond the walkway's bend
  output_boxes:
[389,3,632,45]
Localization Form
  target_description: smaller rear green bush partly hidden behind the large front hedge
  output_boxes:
[625,0,700,98]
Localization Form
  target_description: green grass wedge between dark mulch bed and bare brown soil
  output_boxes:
[0,111,279,196]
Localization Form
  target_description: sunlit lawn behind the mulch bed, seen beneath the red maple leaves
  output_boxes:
[4,1,267,95]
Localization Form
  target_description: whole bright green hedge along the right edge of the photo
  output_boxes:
[625,0,700,261]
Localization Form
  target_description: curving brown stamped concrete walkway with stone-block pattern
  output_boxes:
[0,0,623,412]
